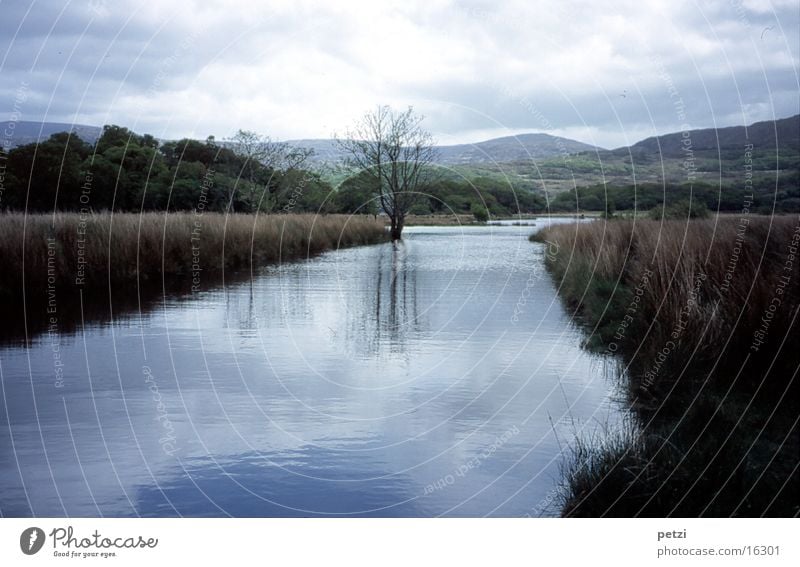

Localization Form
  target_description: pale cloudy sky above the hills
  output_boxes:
[0,0,800,147]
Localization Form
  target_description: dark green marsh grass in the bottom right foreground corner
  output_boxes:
[561,395,800,517]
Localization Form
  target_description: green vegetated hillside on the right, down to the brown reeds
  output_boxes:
[444,122,800,213]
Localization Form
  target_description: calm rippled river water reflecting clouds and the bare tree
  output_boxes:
[0,221,618,516]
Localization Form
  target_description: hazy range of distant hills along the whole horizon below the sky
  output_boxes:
[9,115,800,178]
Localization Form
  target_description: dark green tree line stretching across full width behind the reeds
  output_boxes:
[9,116,780,222]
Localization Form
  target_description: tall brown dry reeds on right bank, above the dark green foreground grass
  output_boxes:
[536,216,800,398]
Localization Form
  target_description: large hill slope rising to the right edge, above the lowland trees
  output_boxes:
[500,115,800,194]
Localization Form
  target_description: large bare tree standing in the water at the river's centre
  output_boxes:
[336,106,436,240]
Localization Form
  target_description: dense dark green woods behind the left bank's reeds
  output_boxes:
[2,126,350,213]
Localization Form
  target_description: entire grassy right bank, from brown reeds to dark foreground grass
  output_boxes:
[535,216,800,516]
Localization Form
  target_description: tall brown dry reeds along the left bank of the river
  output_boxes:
[0,213,385,300]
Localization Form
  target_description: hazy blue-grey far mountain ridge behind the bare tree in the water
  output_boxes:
[289,134,602,165]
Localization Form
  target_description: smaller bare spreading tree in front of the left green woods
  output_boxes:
[228,130,314,209]
